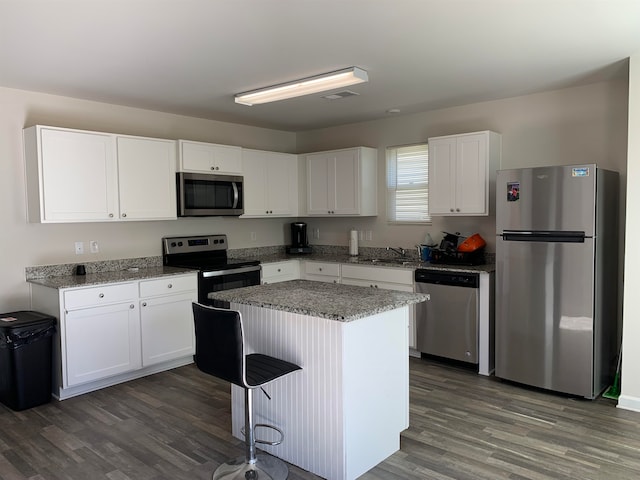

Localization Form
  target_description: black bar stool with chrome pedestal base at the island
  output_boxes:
[193,303,301,480]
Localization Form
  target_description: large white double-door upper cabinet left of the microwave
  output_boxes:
[24,125,176,223]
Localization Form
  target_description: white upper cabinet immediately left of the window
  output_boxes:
[305,147,378,216]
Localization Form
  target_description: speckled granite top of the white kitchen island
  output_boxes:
[209,280,427,322]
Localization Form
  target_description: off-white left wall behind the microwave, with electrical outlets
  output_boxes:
[0,88,295,312]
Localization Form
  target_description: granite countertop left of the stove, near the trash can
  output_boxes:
[27,267,197,289]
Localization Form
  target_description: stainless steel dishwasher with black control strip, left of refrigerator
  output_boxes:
[415,269,480,363]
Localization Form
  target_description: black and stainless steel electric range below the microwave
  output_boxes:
[162,235,260,306]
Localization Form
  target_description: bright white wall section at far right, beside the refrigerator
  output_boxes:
[618,52,640,412]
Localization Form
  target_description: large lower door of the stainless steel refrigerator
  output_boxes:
[496,237,595,398]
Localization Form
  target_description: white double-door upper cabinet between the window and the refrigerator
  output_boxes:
[429,131,501,216]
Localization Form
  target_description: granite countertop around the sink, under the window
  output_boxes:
[260,253,496,273]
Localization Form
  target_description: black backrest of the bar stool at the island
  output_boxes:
[193,303,245,387]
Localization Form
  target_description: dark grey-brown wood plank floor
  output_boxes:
[0,358,640,480]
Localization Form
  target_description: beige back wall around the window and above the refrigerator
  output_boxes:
[298,79,627,251]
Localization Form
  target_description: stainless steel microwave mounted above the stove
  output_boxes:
[176,172,244,217]
